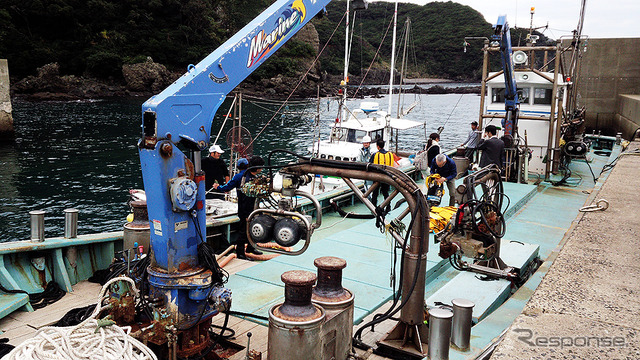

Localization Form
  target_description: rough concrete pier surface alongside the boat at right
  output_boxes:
[491,141,640,360]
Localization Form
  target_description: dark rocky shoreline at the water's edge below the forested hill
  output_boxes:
[11,58,480,101]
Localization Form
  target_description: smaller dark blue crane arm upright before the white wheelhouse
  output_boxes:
[491,15,520,135]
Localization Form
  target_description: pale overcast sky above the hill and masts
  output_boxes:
[370,0,640,39]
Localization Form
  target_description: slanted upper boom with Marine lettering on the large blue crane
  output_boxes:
[142,0,330,150]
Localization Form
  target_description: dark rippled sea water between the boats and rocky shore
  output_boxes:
[0,94,480,242]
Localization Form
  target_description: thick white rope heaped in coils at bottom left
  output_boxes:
[3,276,158,360]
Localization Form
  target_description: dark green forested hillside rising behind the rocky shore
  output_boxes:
[0,0,552,97]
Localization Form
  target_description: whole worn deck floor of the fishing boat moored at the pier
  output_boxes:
[0,141,617,359]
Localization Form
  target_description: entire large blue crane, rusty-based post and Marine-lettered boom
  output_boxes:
[138,0,330,328]
